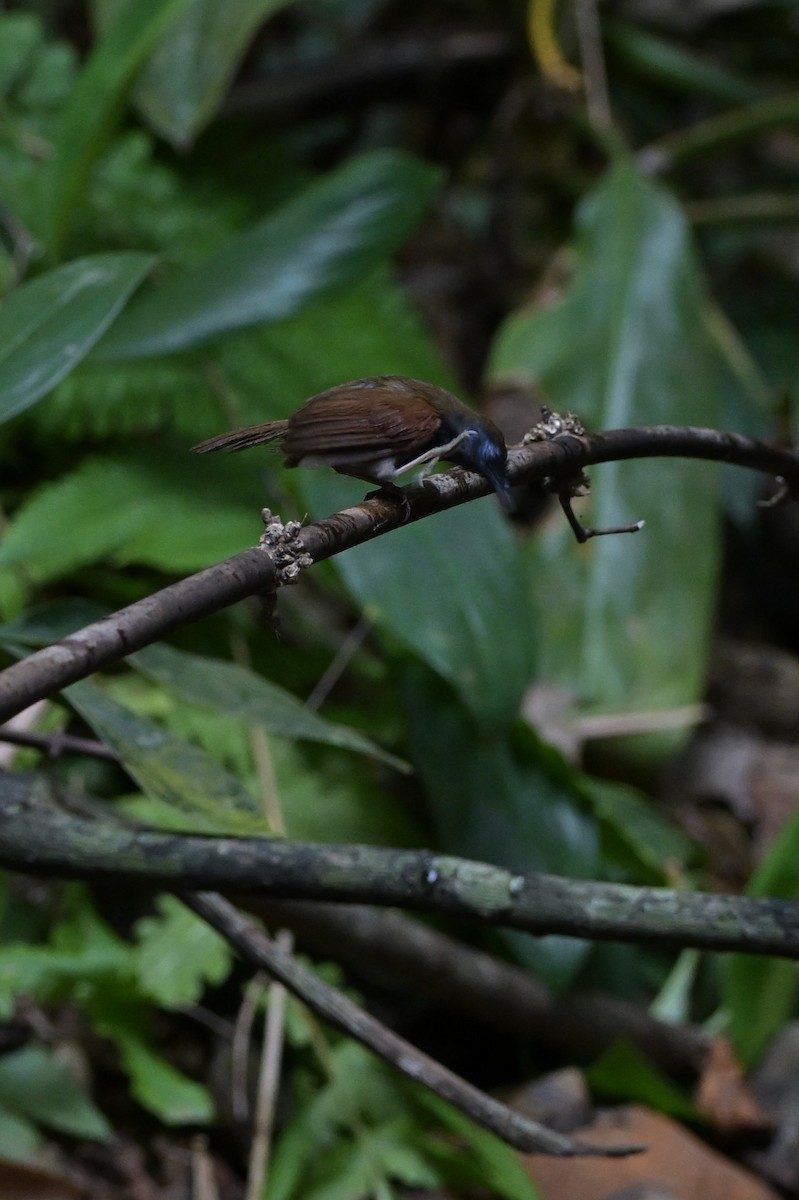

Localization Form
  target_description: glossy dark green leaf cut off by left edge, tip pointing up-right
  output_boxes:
[0,253,154,421]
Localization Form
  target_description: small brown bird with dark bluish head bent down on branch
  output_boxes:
[192,376,512,511]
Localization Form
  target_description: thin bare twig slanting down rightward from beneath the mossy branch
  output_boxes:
[184,892,643,1158]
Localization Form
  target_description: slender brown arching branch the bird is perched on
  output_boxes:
[0,425,799,722]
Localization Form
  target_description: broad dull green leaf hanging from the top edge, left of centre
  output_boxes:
[97,0,292,149]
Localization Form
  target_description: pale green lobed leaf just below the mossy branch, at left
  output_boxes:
[133,895,233,1008]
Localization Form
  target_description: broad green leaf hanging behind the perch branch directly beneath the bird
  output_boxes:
[300,472,534,730]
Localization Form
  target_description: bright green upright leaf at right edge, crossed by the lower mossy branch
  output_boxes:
[722,815,799,1064]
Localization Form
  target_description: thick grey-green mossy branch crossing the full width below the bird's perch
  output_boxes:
[0,775,799,959]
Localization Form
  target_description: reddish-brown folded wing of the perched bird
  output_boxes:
[283,383,440,461]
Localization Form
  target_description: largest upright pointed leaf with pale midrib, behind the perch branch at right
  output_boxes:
[492,161,719,710]
